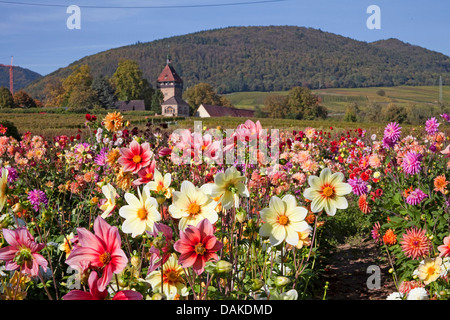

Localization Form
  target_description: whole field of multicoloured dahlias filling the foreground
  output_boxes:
[0,112,450,300]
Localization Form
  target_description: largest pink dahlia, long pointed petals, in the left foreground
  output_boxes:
[66,216,128,291]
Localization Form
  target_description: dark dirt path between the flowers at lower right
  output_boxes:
[324,241,396,300]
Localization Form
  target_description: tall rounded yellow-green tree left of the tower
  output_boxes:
[111,60,149,101]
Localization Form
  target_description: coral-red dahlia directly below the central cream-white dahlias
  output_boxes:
[173,219,223,274]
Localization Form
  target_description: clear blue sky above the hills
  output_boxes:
[0,0,450,75]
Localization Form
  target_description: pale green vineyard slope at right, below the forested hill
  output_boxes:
[226,86,450,114]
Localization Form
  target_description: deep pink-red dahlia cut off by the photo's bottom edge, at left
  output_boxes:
[63,271,142,300]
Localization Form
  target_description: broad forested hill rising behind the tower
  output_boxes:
[27,26,450,95]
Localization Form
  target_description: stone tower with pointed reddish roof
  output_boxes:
[156,56,189,117]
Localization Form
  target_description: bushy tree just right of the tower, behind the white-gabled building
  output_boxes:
[183,82,233,114]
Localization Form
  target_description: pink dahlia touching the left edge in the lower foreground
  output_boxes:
[0,227,48,276]
